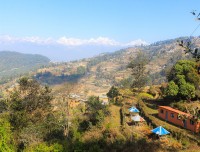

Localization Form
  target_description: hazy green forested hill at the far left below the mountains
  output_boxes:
[0,51,50,83]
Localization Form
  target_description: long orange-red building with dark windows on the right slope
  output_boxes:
[158,106,200,133]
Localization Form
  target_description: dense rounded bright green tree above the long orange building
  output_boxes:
[165,60,200,100]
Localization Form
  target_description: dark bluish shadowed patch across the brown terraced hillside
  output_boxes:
[35,72,85,85]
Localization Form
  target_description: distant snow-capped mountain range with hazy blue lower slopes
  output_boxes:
[0,36,148,62]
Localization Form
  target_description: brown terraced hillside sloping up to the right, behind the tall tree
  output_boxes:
[32,38,200,96]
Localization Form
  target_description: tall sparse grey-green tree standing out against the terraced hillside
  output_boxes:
[128,51,148,88]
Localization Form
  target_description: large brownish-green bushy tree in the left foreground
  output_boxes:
[8,77,57,149]
